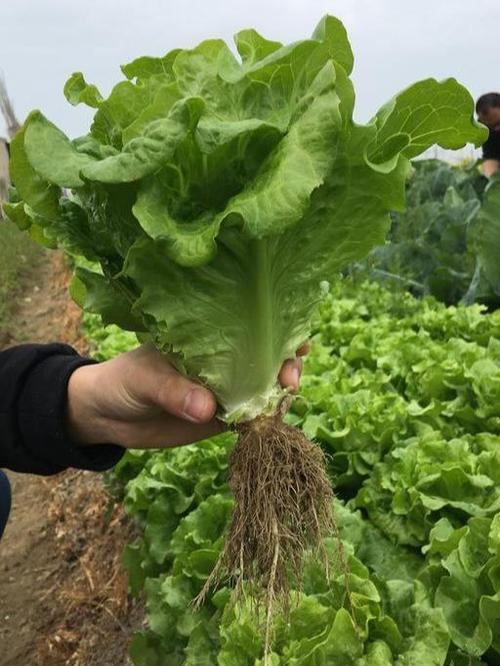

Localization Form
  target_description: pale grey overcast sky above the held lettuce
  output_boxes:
[0,0,500,137]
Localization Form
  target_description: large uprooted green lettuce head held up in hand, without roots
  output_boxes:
[7,16,486,420]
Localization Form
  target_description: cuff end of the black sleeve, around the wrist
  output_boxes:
[18,354,124,474]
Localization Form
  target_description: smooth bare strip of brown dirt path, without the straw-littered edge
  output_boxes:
[0,255,75,666]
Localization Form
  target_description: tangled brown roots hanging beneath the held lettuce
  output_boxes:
[197,414,338,653]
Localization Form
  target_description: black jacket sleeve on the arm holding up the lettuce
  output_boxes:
[0,344,124,475]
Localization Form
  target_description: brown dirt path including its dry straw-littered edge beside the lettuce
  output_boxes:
[0,253,140,666]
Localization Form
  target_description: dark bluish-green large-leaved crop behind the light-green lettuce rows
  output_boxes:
[351,160,500,309]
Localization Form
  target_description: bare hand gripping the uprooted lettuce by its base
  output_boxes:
[68,343,309,448]
